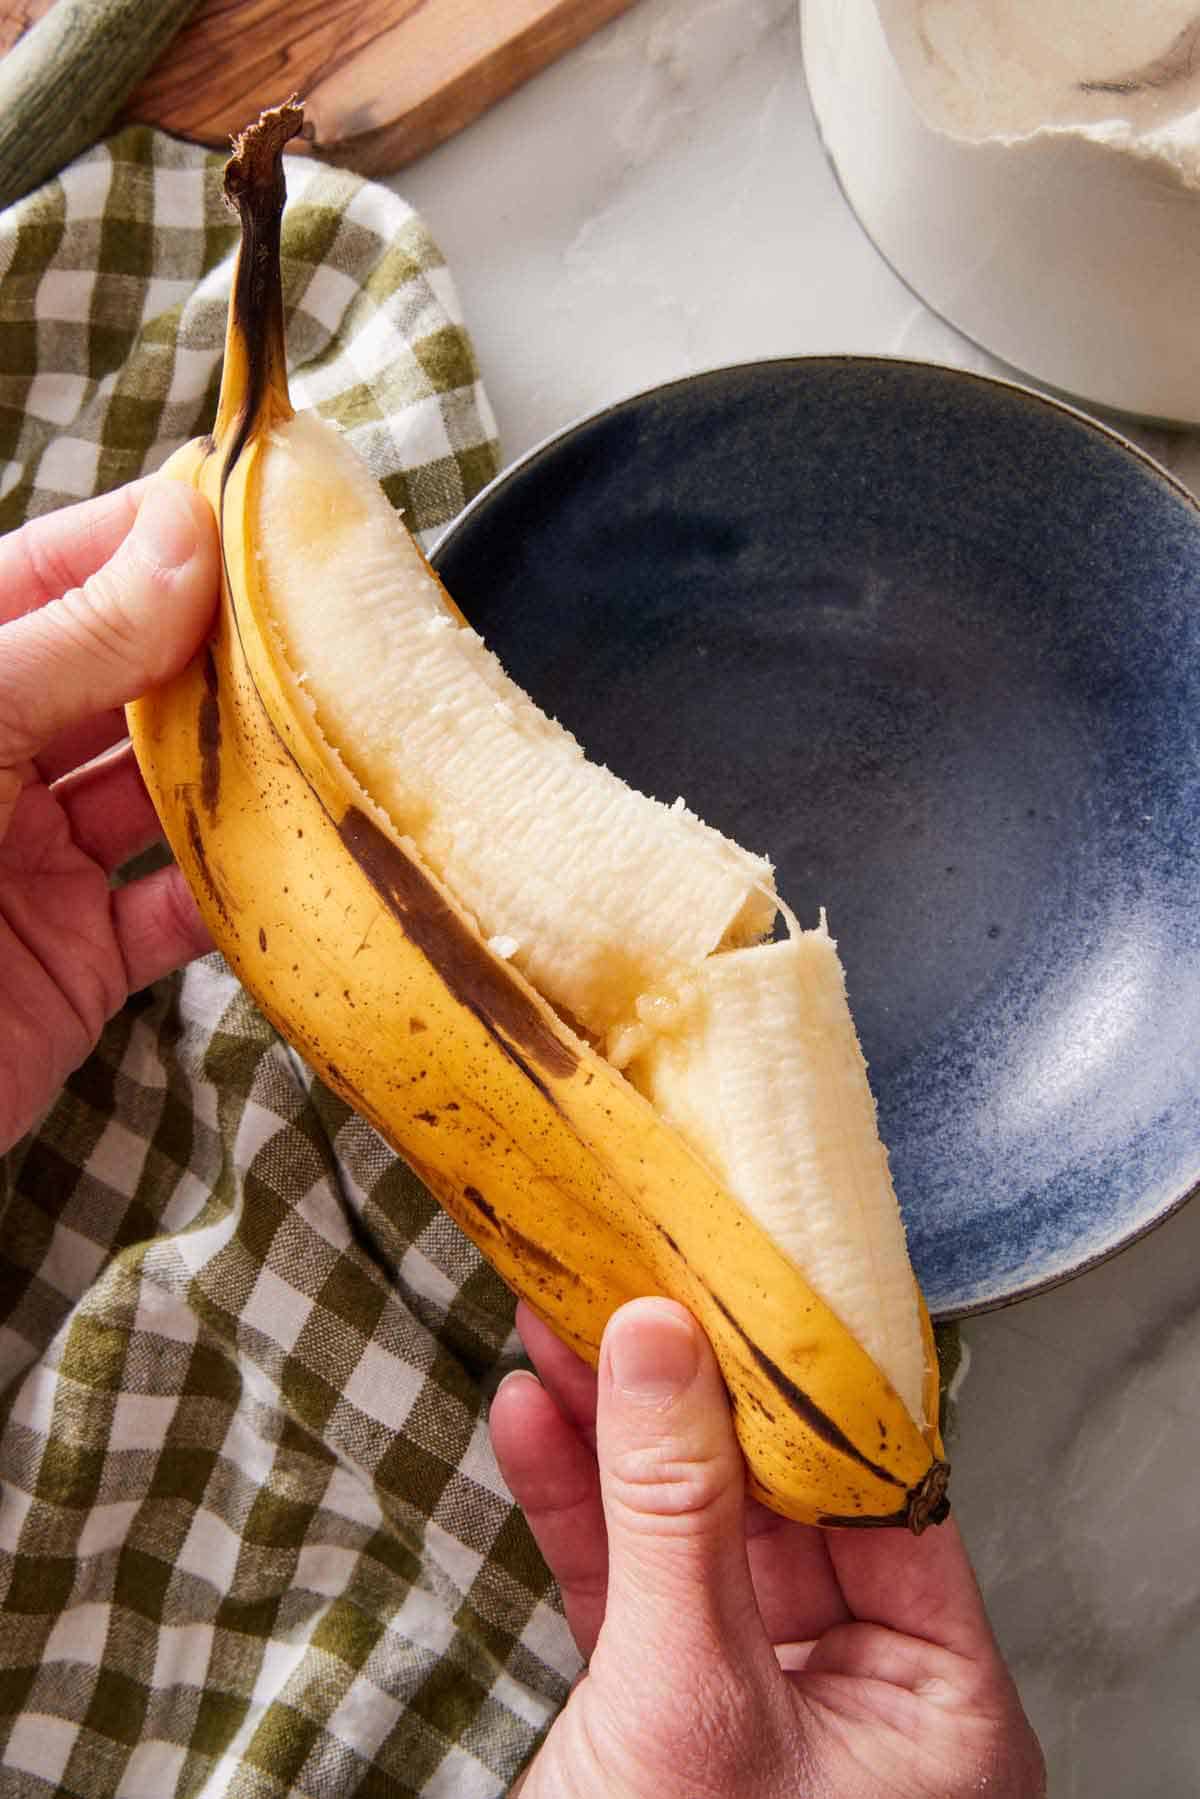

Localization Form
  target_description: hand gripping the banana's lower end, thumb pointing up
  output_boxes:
[491,1299,1045,1799]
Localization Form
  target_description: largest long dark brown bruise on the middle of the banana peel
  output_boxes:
[336,806,579,1099]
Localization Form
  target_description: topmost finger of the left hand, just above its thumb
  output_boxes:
[0,480,148,624]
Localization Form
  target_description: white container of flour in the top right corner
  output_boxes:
[801,0,1200,423]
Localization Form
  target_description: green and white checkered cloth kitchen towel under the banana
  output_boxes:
[0,130,578,1799]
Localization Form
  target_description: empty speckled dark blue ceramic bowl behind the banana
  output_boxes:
[435,356,1200,1317]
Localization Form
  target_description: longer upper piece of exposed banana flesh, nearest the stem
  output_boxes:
[259,414,775,1036]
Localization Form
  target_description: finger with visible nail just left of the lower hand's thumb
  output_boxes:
[489,1371,608,1660]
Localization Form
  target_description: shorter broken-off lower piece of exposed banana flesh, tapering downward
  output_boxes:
[626,921,925,1418]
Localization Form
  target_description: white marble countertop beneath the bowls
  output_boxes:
[392,0,1200,1799]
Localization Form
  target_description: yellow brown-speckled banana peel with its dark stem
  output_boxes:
[130,104,948,1529]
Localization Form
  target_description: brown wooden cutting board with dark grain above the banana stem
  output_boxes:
[0,0,633,175]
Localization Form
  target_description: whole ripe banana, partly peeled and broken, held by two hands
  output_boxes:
[130,104,948,1531]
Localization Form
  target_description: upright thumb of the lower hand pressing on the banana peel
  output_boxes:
[596,1299,770,1684]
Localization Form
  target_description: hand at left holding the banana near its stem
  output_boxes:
[0,480,218,1151]
